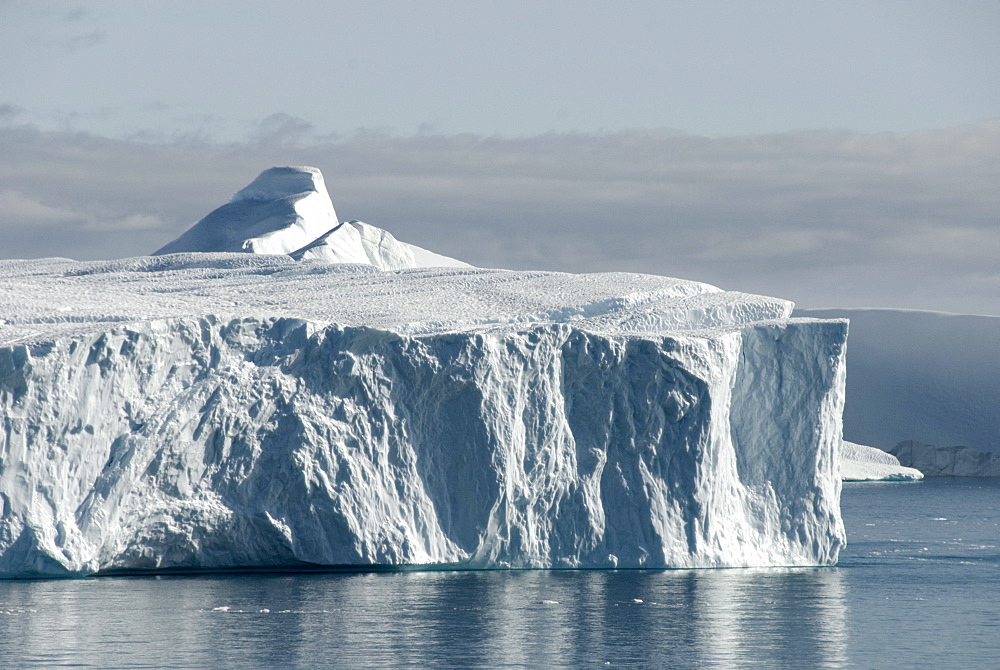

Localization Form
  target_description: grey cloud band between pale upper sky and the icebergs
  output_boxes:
[0,121,1000,314]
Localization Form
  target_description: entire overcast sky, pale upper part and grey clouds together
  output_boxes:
[0,0,1000,315]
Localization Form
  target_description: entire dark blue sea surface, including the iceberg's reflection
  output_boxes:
[0,479,1000,668]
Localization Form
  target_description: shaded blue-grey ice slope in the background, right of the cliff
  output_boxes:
[796,309,1000,476]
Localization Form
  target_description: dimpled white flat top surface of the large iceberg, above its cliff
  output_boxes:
[0,253,792,346]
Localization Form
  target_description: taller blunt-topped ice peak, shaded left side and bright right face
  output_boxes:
[153,167,339,256]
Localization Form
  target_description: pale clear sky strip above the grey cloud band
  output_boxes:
[0,0,1000,140]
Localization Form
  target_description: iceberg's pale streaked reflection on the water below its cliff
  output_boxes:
[0,569,848,668]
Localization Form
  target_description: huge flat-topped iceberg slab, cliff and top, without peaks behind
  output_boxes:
[0,254,846,576]
